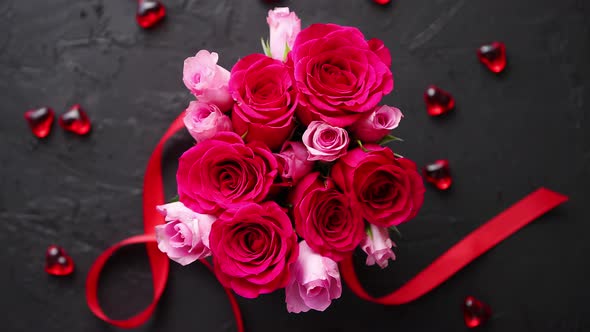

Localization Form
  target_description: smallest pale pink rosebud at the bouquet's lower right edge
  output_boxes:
[361,224,396,269]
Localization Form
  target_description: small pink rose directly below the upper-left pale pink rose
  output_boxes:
[184,101,232,143]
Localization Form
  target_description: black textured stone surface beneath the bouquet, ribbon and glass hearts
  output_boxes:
[0,0,590,332]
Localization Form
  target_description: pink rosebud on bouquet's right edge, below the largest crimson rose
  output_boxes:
[350,105,404,143]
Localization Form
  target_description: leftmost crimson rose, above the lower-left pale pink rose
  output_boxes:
[176,132,278,215]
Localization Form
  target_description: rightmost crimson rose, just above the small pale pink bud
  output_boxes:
[332,144,424,227]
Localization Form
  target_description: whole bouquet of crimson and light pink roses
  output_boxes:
[156,8,424,313]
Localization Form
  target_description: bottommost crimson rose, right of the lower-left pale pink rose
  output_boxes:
[209,202,299,298]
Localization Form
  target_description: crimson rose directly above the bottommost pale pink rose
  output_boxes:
[290,172,365,261]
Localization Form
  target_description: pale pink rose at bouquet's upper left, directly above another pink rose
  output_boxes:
[182,50,233,112]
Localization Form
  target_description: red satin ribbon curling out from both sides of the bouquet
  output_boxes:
[86,116,568,332]
